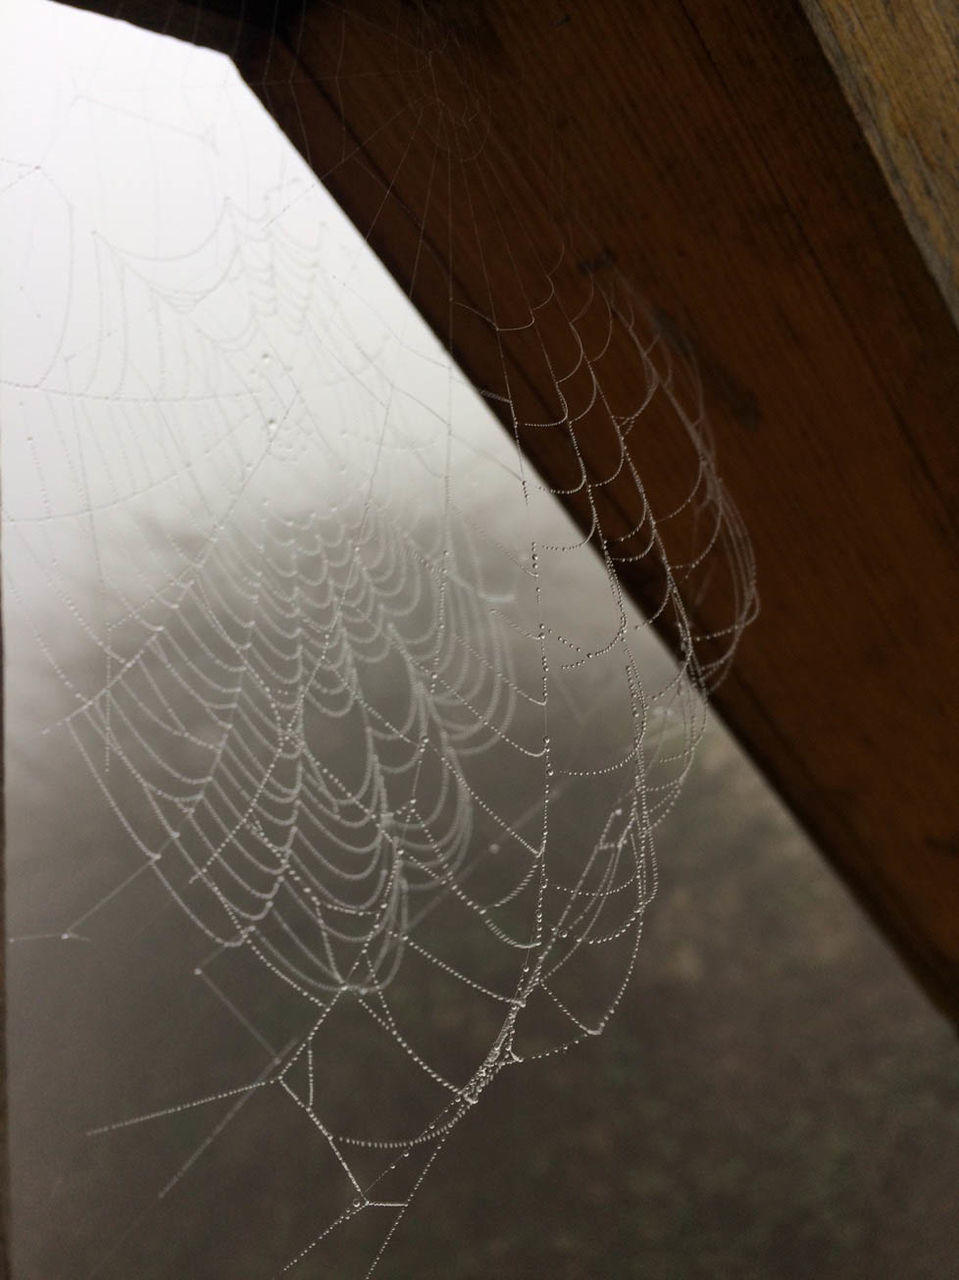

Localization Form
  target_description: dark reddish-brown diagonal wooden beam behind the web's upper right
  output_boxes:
[54,0,959,1015]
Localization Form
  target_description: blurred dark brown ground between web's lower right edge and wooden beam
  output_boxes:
[383,733,959,1280]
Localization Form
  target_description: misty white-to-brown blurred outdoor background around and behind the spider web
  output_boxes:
[0,4,959,1280]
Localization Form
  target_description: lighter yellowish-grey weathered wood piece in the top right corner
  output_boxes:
[803,0,959,330]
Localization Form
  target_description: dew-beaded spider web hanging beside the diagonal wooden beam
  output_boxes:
[0,6,754,1276]
